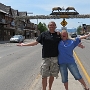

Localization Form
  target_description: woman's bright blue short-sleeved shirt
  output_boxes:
[58,37,81,64]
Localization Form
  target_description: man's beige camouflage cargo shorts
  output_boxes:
[40,57,59,78]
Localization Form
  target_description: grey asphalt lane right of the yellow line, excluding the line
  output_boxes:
[75,39,90,76]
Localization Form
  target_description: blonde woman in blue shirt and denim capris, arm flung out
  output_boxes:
[58,30,90,90]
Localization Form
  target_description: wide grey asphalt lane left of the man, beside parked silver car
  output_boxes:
[0,39,41,90]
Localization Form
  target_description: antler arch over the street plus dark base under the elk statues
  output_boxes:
[14,6,90,20]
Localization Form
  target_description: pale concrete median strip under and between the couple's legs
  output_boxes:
[29,72,84,90]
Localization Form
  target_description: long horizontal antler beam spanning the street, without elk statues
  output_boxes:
[15,14,90,20]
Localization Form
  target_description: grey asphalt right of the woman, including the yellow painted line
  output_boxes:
[74,39,90,86]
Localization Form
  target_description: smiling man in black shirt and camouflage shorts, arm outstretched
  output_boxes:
[17,21,61,90]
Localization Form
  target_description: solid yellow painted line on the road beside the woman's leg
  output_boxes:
[74,52,90,84]
